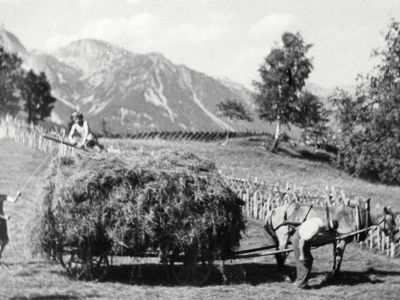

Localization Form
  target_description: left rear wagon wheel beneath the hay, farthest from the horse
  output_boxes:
[59,250,110,281]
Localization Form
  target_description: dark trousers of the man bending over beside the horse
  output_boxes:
[292,229,314,287]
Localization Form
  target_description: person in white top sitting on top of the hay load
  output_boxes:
[68,111,104,151]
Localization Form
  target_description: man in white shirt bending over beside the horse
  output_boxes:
[292,218,338,288]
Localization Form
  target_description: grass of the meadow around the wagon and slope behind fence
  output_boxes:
[0,140,400,300]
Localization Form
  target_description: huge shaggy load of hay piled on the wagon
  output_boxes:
[31,151,244,256]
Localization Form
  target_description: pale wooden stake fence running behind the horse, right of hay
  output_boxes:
[225,176,400,258]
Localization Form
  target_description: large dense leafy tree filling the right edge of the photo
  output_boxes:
[336,21,400,184]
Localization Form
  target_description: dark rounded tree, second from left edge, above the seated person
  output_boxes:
[21,70,56,124]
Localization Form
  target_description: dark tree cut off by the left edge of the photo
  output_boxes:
[0,47,23,115]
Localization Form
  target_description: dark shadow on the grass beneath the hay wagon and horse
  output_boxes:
[50,260,400,288]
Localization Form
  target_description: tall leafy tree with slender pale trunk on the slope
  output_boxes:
[253,32,313,151]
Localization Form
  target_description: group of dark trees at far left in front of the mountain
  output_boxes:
[0,47,56,124]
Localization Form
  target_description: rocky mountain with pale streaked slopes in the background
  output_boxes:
[0,29,253,133]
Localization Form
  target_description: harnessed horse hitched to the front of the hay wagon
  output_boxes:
[264,199,400,279]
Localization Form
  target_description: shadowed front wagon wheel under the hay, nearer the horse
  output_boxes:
[171,245,213,286]
